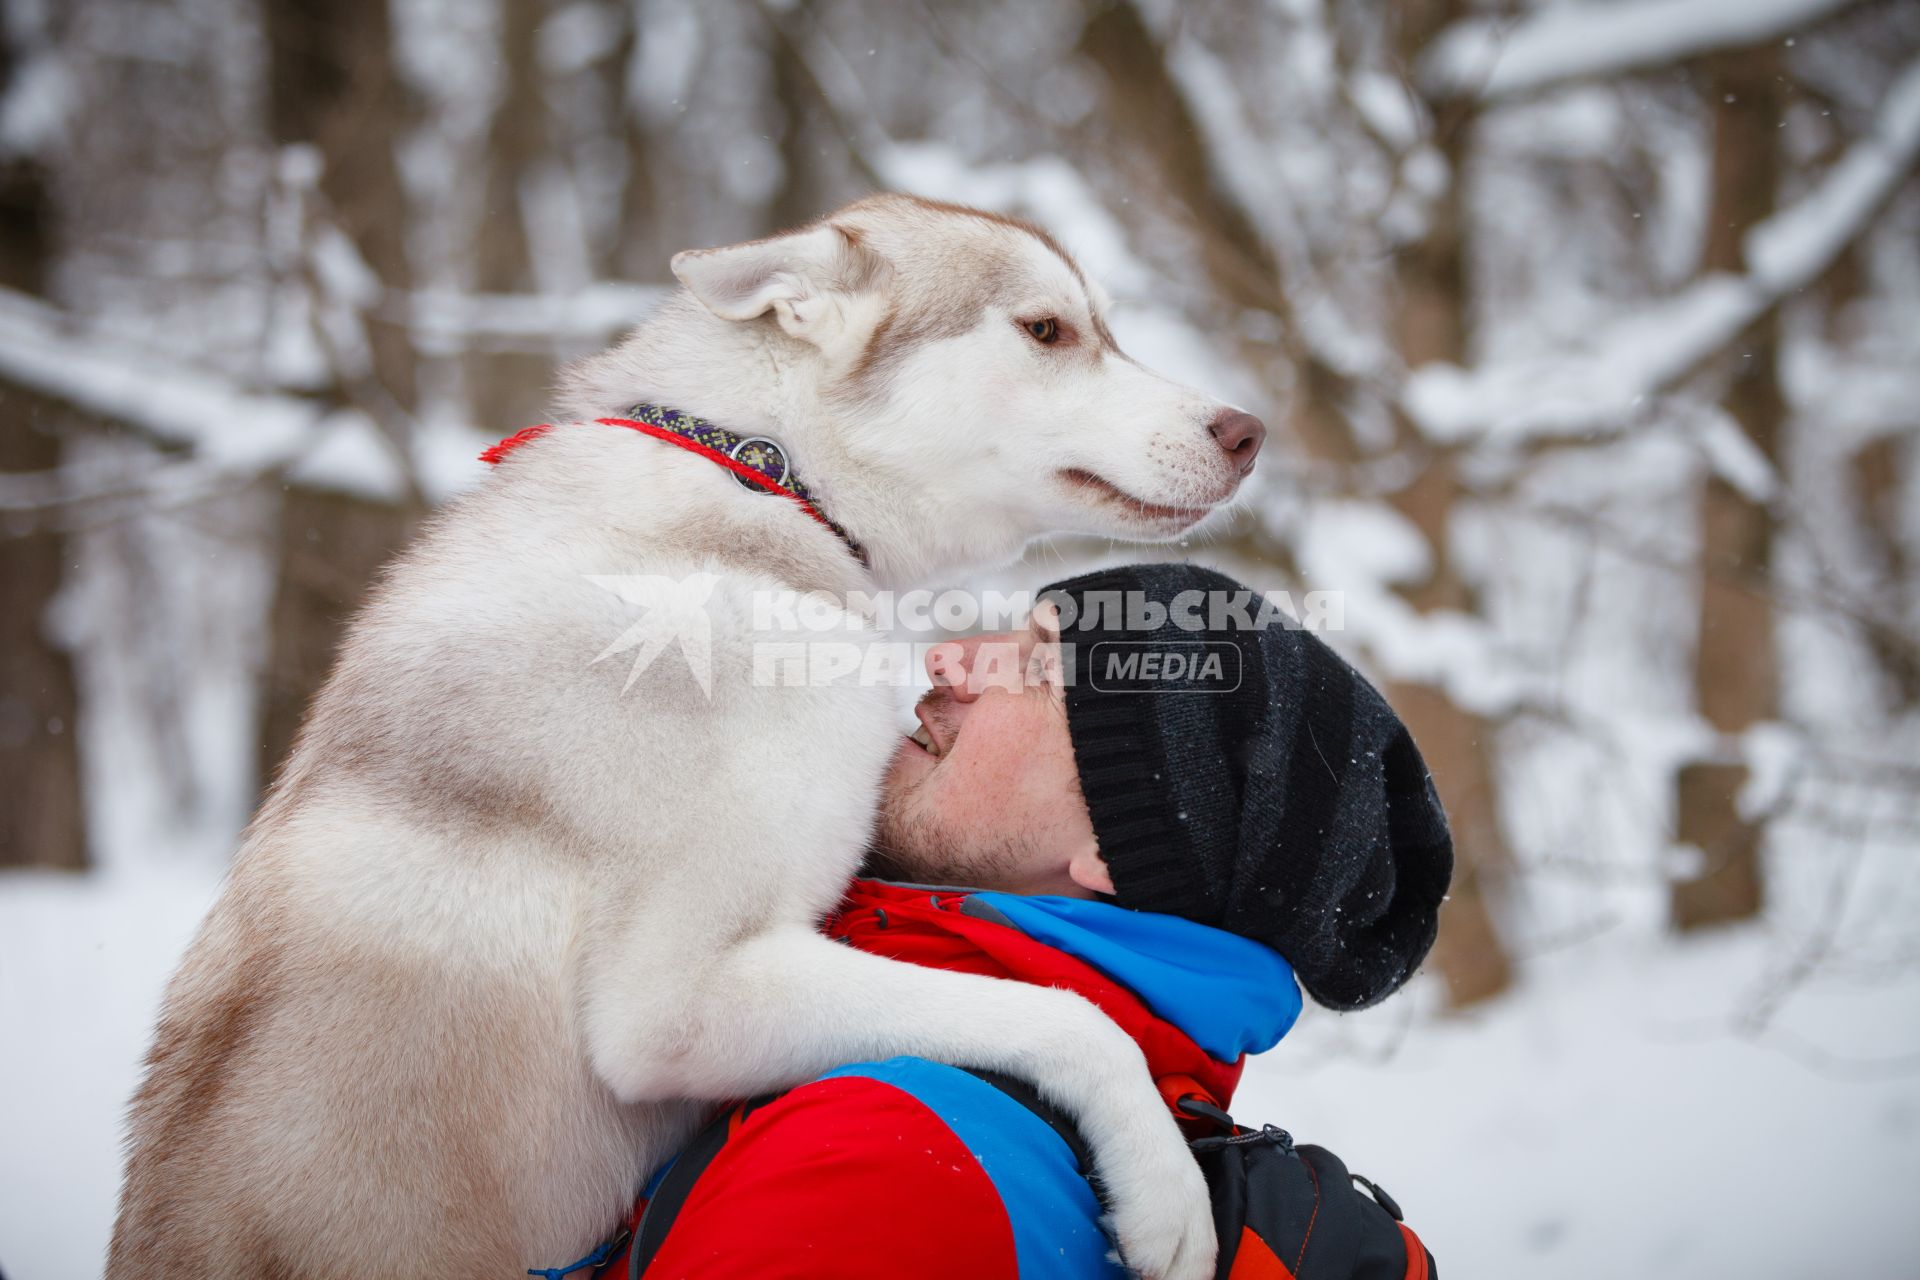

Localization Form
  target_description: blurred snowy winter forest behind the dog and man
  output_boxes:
[0,0,1920,1280]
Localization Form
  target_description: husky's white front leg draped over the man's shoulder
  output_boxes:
[588,927,1215,1280]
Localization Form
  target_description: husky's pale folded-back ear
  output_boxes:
[672,223,885,347]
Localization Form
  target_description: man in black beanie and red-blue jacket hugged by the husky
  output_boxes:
[560,564,1452,1280]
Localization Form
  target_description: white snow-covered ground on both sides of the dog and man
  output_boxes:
[0,875,1920,1280]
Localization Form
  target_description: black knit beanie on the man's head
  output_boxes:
[1044,564,1453,1009]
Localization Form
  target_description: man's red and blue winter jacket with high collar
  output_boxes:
[574,881,1300,1280]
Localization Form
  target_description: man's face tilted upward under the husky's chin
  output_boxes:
[870,606,1114,898]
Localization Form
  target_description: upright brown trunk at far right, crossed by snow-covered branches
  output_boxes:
[1672,46,1786,929]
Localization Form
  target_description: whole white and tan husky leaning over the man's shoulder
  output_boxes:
[108,196,1261,1280]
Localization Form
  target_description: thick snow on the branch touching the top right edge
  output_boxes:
[1419,0,1857,100]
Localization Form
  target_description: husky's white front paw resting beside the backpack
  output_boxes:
[1102,1113,1219,1280]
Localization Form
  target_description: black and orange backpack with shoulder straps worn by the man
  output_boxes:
[614,1071,1440,1280]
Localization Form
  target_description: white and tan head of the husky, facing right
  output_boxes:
[574,196,1265,574]
